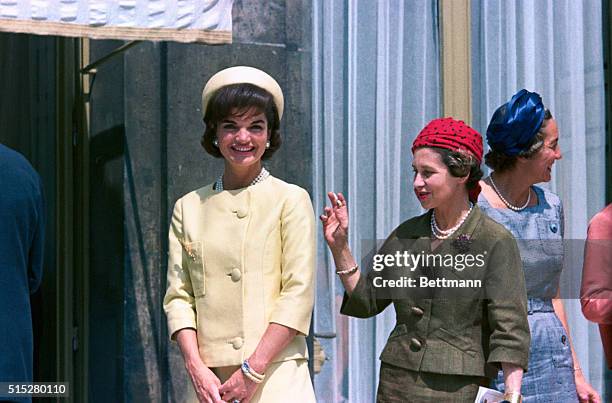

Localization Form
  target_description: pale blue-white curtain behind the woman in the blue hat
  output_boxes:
[472,0,606,393]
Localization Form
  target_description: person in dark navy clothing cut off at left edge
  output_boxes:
[0,144,45,402]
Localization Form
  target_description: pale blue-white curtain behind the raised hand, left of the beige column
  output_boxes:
[312,0,440,403]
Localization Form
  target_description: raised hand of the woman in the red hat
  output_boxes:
[319,192,349,252]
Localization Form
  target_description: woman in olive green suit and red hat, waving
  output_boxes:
[320,118,530,403]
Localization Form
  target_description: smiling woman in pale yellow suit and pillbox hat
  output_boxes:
[164,66,315,403]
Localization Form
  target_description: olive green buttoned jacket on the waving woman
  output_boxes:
[341,206,530,377]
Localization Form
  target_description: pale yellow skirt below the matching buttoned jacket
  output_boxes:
[188,360,316,403]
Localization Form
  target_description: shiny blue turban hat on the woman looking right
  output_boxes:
[487,89,544,156]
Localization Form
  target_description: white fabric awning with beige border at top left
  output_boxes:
[0,0,233,44]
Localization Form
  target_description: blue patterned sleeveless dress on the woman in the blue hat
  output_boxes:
[478,186,578,403]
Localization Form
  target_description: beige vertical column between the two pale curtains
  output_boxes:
[439,0,472,124]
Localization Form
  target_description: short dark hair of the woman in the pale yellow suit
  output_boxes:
[200,83,282,160]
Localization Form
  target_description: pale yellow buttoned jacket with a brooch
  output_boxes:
[164,176,315,367]
